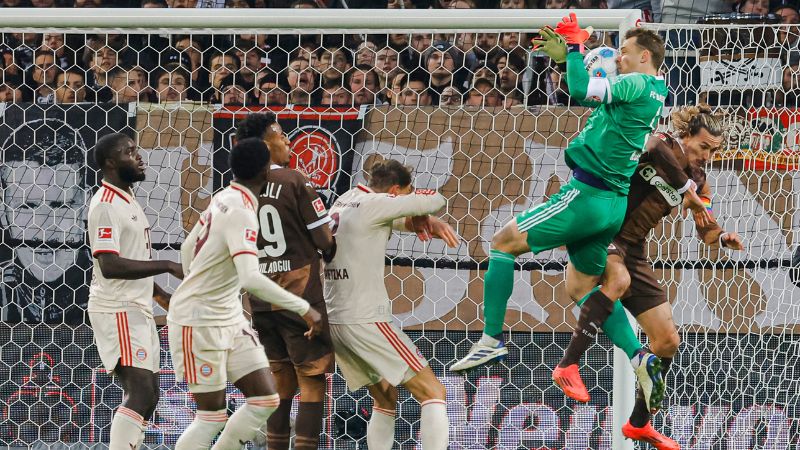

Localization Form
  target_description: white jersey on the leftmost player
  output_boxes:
[88,182,153,316]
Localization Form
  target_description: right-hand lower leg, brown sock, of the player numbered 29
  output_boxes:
[294,373,326,450]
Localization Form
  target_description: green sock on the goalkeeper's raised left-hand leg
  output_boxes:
[483,250,516,336]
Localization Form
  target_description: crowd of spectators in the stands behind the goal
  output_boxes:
[0,0,800,108]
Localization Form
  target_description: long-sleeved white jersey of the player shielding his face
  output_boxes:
[325,184,446,324]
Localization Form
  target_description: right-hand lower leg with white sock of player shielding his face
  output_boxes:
[403,367,450,450]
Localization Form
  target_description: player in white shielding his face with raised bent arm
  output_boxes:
[325,160,458,450]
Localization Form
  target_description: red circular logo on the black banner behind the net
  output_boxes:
[289,126,340,189]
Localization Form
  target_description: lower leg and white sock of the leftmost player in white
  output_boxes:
[109,364,159,450]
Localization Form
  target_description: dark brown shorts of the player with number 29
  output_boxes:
[253,302,334,376]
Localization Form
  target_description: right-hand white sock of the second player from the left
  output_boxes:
[211,394,281,450]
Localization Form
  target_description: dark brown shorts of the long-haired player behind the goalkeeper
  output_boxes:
[608,239,669,317]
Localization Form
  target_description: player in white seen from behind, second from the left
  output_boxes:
[167,138,322,450]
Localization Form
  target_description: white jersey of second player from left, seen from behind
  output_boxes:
[167,182,258,326]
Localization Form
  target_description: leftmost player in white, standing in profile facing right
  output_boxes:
[88,133,183,450]
